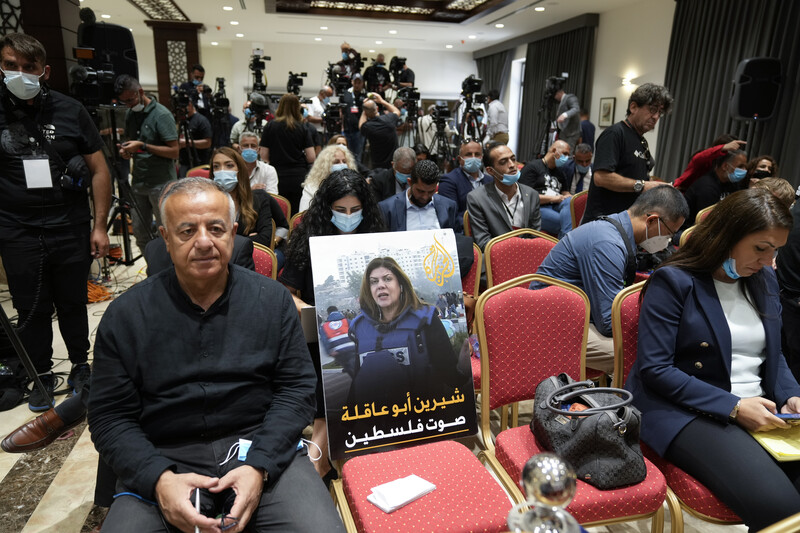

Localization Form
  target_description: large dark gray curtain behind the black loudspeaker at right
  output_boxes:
[653,0,800,185]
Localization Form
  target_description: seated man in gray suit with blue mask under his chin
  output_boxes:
[467,142,542,250]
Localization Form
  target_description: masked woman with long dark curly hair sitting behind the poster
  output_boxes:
[278,169,384,480]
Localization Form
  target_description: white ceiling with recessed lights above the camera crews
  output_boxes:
[80,0,640,54]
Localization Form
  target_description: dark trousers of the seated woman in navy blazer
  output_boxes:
[665,417,800,531]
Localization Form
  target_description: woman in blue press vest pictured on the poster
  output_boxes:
[348,257,471,405]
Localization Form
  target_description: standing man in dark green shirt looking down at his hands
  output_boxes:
[114,74,178,253]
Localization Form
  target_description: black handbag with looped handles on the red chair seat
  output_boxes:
[531,373,647,490]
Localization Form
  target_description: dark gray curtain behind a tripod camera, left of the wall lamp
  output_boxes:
[517,26,595,161]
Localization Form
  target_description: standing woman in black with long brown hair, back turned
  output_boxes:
[259,93,315,213]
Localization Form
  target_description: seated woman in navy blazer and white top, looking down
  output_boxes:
[625,189,800,531]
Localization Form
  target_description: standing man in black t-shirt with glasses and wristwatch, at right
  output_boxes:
[583,83,672,223]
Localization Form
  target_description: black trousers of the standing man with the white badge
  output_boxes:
[0,227,92,373]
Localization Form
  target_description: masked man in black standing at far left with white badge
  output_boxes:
[0,33,111,411]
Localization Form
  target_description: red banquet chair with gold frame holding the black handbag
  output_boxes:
[476,274,667,533]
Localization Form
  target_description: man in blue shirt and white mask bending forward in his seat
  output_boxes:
[531,187,689,373]
